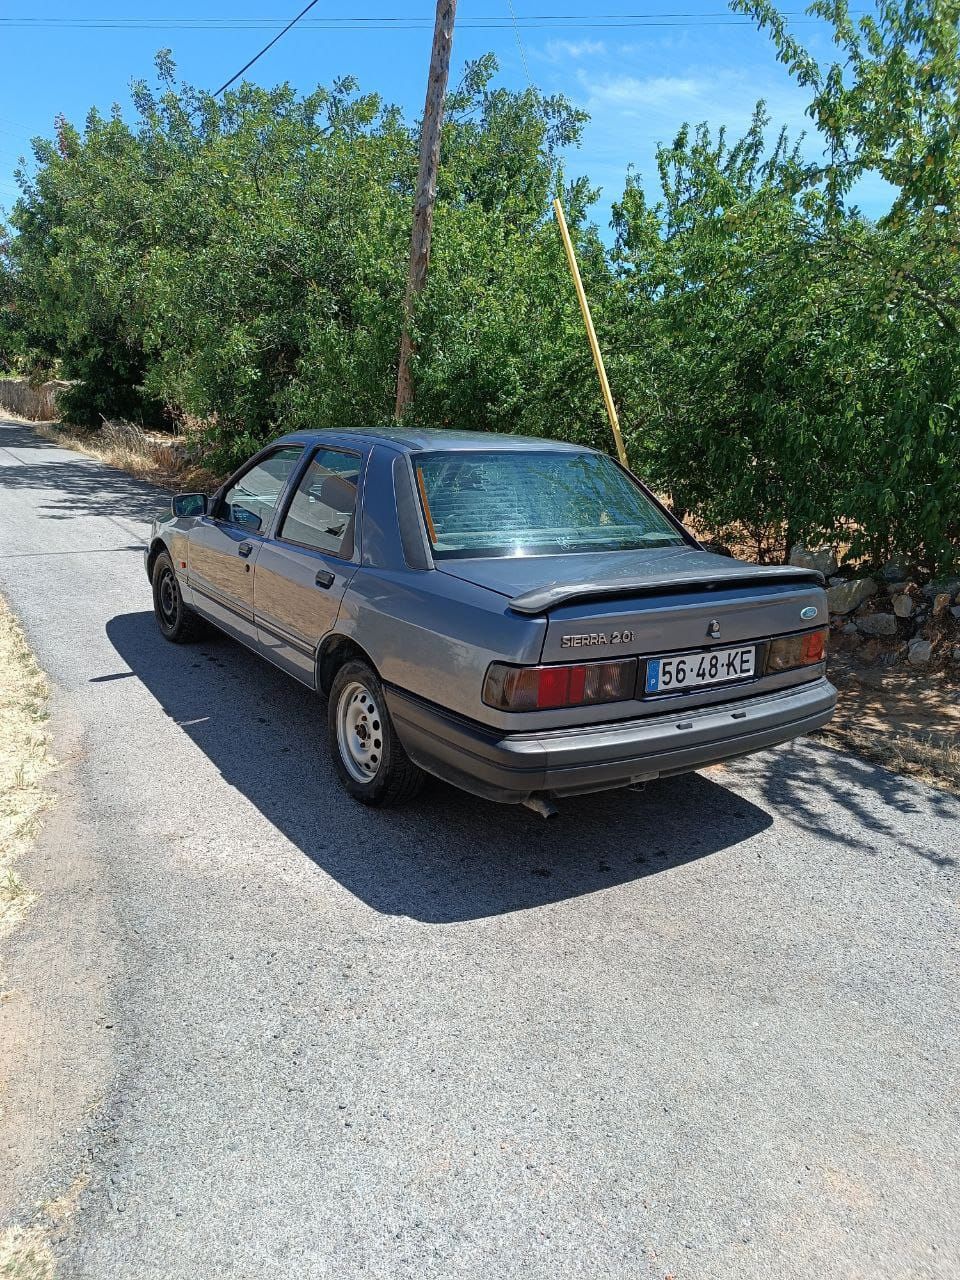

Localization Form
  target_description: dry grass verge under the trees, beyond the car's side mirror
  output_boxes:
[29,422,220,493]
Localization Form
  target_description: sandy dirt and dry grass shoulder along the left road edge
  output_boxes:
[0,599,108,1280]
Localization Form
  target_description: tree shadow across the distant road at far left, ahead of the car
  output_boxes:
[0,420,170,522]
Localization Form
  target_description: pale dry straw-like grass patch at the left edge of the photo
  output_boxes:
[0,599,52,942]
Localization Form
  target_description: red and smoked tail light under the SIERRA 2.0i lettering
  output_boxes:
[484,658,636,712]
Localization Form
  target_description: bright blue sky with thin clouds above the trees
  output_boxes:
[0,0,887,227]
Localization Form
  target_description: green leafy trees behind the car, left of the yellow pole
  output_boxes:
[0,56,602,463]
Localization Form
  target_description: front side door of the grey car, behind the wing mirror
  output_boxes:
[187,444,303,644]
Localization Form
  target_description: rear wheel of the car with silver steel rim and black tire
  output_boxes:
[326,659,424,808]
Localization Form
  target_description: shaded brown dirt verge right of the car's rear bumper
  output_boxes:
[819,654,960,792]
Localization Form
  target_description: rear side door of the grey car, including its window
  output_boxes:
[253,448,364,686]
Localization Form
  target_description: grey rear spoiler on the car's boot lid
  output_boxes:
[508,561,823,614]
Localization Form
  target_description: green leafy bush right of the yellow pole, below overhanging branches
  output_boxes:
[616,114,960,568]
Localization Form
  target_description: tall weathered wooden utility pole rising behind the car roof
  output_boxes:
[394,0,457,419]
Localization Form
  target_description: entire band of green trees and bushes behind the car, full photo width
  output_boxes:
[0,0,960,572]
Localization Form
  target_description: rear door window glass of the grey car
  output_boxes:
[279,449,360,559]
